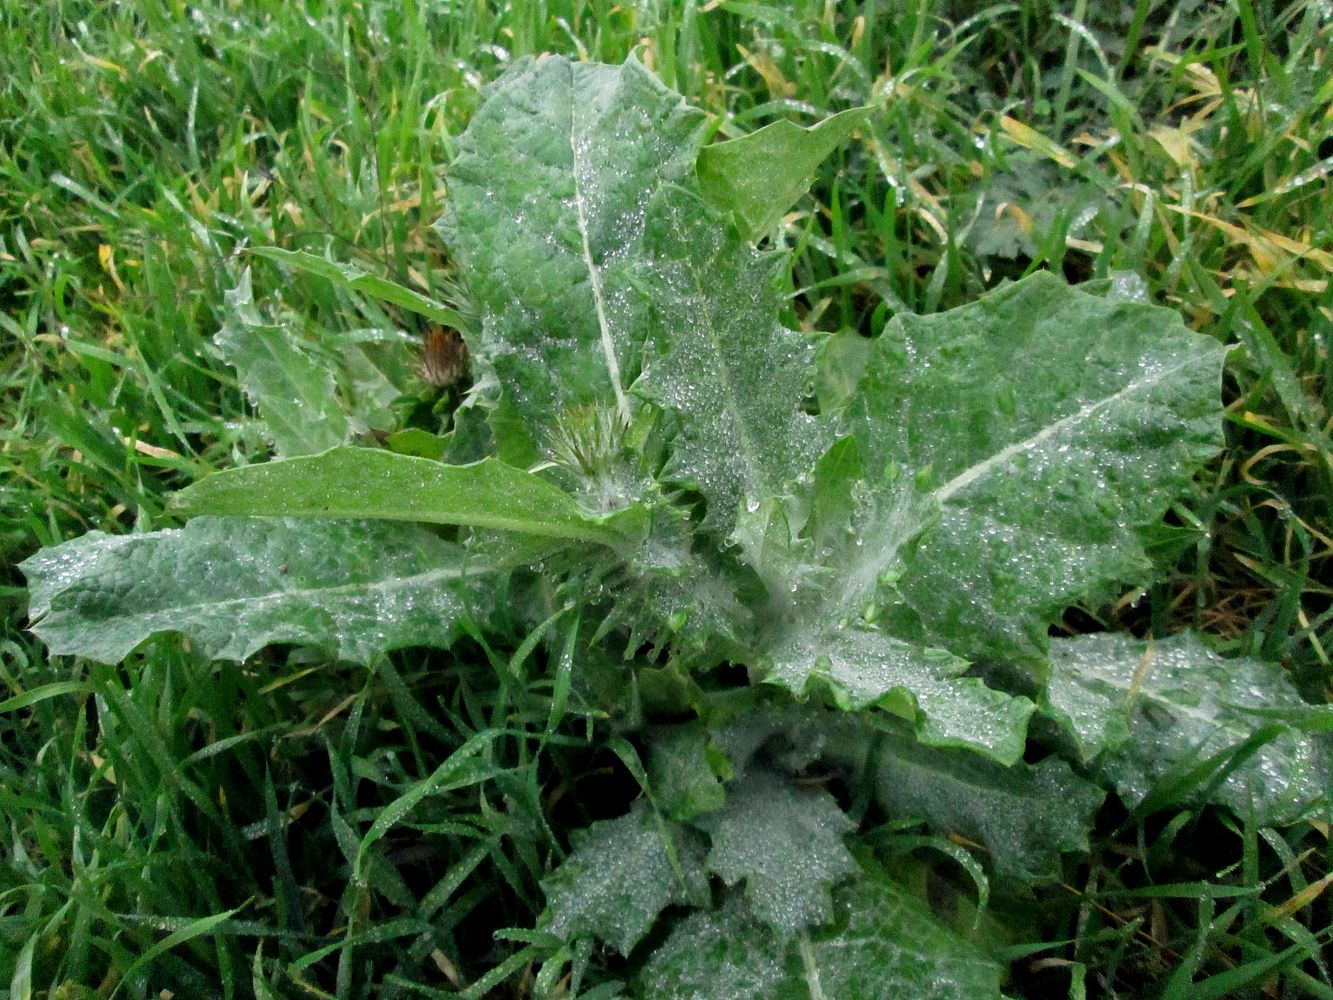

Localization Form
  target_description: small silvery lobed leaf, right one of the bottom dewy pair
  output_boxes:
[700,769,857,937]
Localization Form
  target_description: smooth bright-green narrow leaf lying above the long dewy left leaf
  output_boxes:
[172,447,641,545]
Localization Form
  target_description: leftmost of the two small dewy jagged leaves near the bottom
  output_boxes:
[541,799,708,955]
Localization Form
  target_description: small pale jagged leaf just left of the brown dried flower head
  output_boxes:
[213,269,349,456]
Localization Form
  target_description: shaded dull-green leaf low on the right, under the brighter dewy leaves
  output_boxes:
[828,719,1105,881]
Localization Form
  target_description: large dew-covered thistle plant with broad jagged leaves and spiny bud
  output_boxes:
[18,57,1301,997]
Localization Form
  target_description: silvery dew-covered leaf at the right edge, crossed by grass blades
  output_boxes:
[1046,632,1333,824]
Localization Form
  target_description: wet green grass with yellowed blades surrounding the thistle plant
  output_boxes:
[0,0,1333,1000]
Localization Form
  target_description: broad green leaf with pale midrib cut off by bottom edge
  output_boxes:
[637,873,1001,1000]
